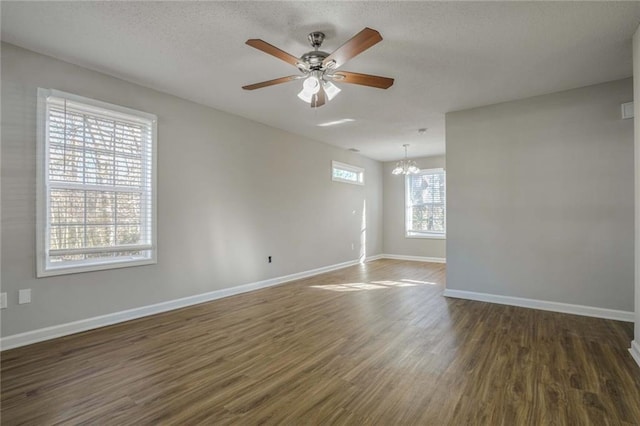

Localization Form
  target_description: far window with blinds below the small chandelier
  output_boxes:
[405,169,446,238]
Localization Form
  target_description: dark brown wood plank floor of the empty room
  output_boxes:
[1,260,640,426]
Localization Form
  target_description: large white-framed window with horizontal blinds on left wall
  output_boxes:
[37,89,156,276]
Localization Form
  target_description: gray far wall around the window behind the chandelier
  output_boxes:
[382,155,446,258]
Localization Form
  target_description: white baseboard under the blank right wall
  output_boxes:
[444,289,635,322]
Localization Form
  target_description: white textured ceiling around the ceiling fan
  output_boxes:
[1,1,640,161]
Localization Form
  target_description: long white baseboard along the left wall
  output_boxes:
[0,260,359,351]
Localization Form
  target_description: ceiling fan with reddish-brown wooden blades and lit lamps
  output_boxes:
[242,28,393,108]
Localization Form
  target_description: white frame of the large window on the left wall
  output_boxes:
[36,88,158,278]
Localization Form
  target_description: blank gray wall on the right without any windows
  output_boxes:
[446,78,634,311]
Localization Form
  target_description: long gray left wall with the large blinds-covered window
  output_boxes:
[1,44,382,336]
